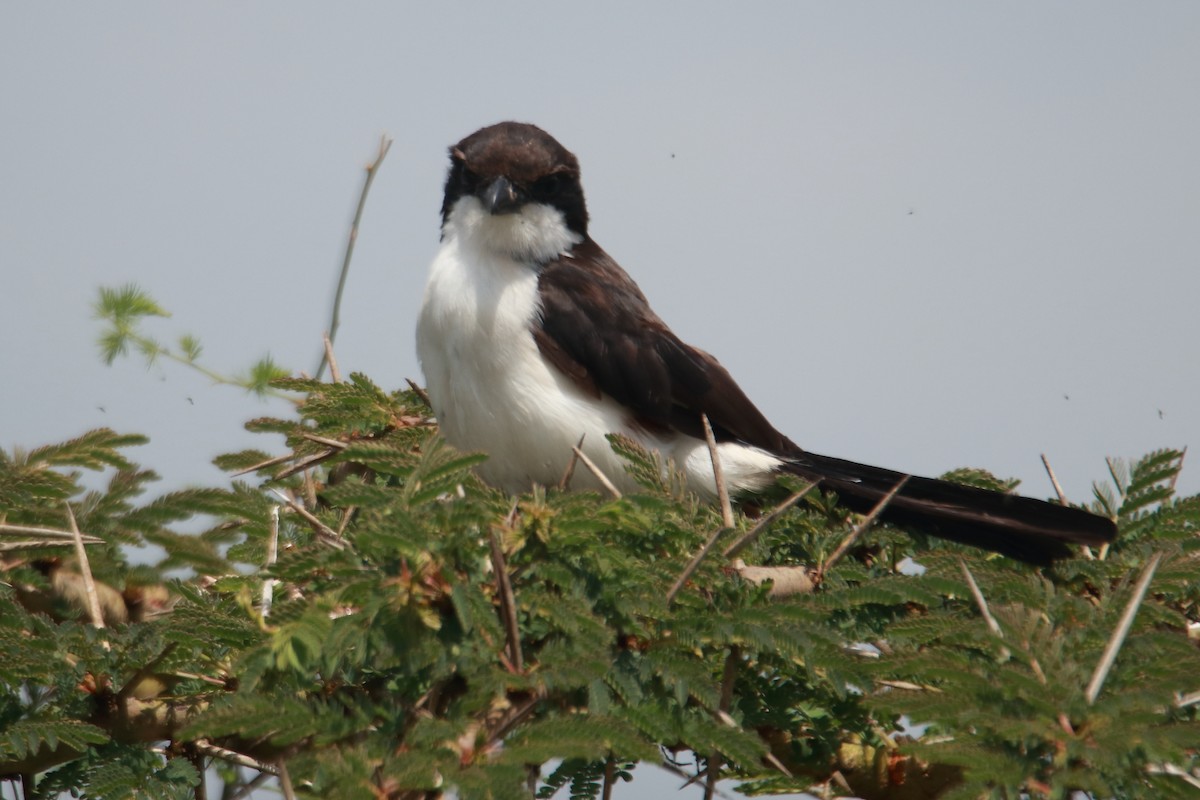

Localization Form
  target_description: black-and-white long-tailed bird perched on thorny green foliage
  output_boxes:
[416,121,1116,565]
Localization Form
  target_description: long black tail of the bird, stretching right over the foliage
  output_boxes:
[785,451,1117,564]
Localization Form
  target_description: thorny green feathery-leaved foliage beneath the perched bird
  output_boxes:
[0,371,1200,800]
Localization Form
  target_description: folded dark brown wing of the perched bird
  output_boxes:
[534,239,796,453]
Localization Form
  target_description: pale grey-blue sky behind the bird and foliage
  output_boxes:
[0,0,1200,798]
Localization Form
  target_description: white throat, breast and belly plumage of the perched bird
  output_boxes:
[416,198,780,494]
